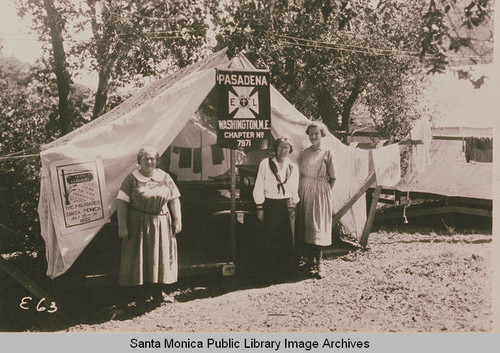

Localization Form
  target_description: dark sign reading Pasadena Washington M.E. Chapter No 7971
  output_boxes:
[215,70,271,149]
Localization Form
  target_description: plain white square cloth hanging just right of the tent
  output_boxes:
[371,143,401,186]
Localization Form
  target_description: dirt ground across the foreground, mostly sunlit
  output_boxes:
[0,227,493,332]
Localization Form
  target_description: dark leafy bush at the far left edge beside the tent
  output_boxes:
[0,56,91,248]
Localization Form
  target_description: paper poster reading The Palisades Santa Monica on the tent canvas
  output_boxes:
[50,157,109,235]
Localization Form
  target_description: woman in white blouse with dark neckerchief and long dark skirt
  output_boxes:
[253,136,299,270]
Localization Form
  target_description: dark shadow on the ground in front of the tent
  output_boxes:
[0,240,357,332]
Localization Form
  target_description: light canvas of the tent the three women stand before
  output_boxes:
[38,50,390,278]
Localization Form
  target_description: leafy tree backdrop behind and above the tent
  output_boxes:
[0,0,494,258]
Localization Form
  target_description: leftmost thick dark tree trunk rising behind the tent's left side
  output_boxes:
[43,0,71,135]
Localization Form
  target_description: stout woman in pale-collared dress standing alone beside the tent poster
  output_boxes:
[117,147,182,301]
